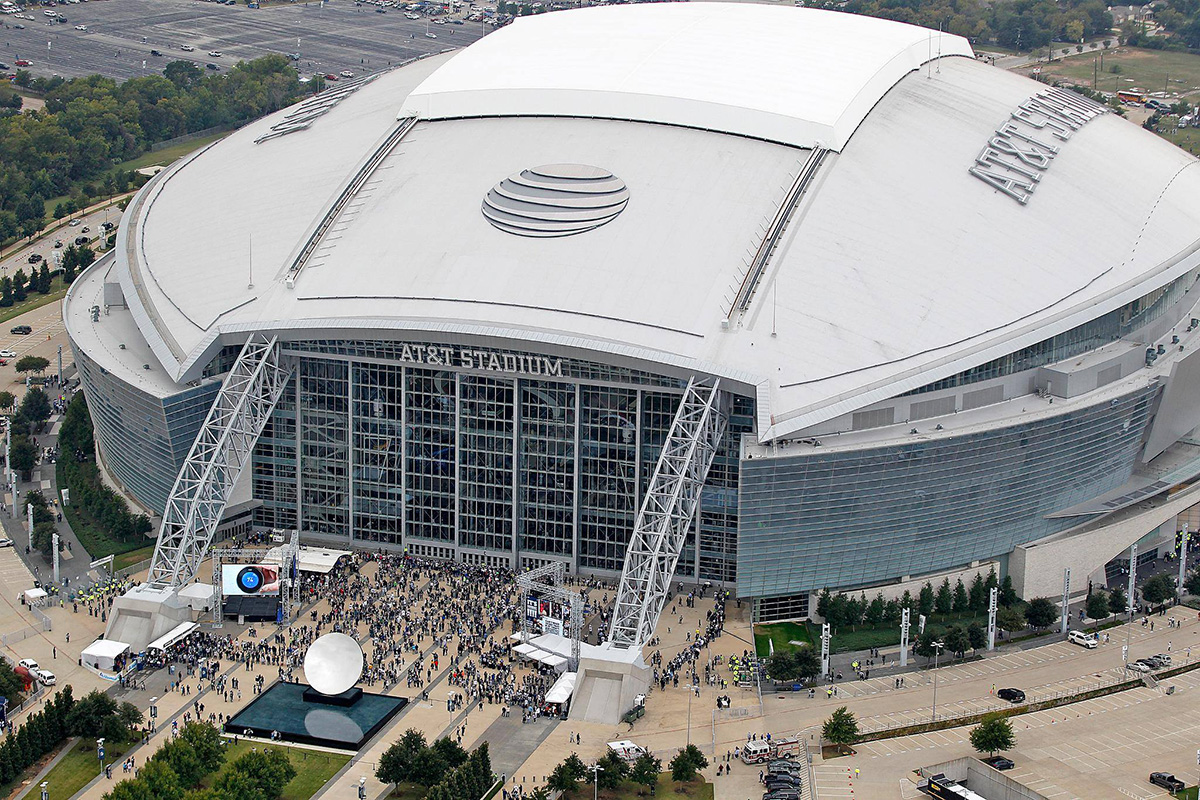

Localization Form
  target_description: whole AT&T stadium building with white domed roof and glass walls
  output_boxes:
[65,4,1200,633]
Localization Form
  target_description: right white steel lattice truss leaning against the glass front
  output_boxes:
[608,379,726,648]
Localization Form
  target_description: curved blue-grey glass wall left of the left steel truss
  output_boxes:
[74,348,221,513]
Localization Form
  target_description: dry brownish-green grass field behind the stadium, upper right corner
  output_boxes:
[1021,47,1200,103]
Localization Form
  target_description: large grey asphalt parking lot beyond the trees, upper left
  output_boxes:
[0,0,491,79]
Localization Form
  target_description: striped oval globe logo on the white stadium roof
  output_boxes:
[482,164,629,239]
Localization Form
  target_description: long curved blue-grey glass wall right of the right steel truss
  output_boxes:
[737,386,1158,597]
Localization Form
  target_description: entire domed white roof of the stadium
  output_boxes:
[66,4,1200,440]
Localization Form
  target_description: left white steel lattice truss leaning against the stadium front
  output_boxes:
[146,335,290,587]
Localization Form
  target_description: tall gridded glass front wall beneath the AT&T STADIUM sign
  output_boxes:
[243,341,754,582]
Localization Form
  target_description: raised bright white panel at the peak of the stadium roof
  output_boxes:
[401,2,972,150]
